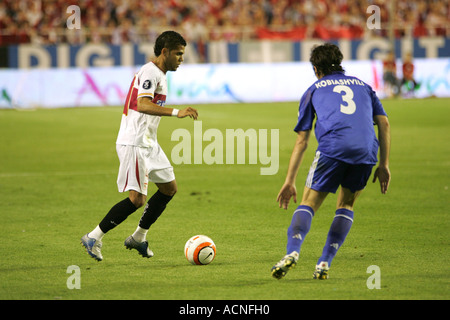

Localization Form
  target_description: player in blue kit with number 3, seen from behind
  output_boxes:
[271,43,391,279]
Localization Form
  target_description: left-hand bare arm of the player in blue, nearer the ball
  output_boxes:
[277,130,311,210]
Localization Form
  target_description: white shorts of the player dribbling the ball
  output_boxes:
[116,144,175,195]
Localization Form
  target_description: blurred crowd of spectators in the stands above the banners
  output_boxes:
[0,0,450,45]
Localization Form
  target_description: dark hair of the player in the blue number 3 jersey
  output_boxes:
[309,43,345,76]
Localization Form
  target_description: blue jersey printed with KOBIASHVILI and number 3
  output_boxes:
[294,72,386,164]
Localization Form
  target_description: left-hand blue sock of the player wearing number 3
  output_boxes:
[286,205,314,254]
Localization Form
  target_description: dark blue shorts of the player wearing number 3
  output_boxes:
[306,151,374,193]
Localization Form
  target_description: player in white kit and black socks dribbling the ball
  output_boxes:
[81,31,198,261]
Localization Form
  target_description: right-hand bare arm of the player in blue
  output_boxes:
[373,115,391,194]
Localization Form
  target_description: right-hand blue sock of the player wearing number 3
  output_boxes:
[317,209,353,266]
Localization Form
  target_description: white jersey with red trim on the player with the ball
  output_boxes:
[116,62,167,148]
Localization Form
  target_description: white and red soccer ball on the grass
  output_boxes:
[184,235,216,265]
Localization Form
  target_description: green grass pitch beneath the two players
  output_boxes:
[0,99,450,300]
